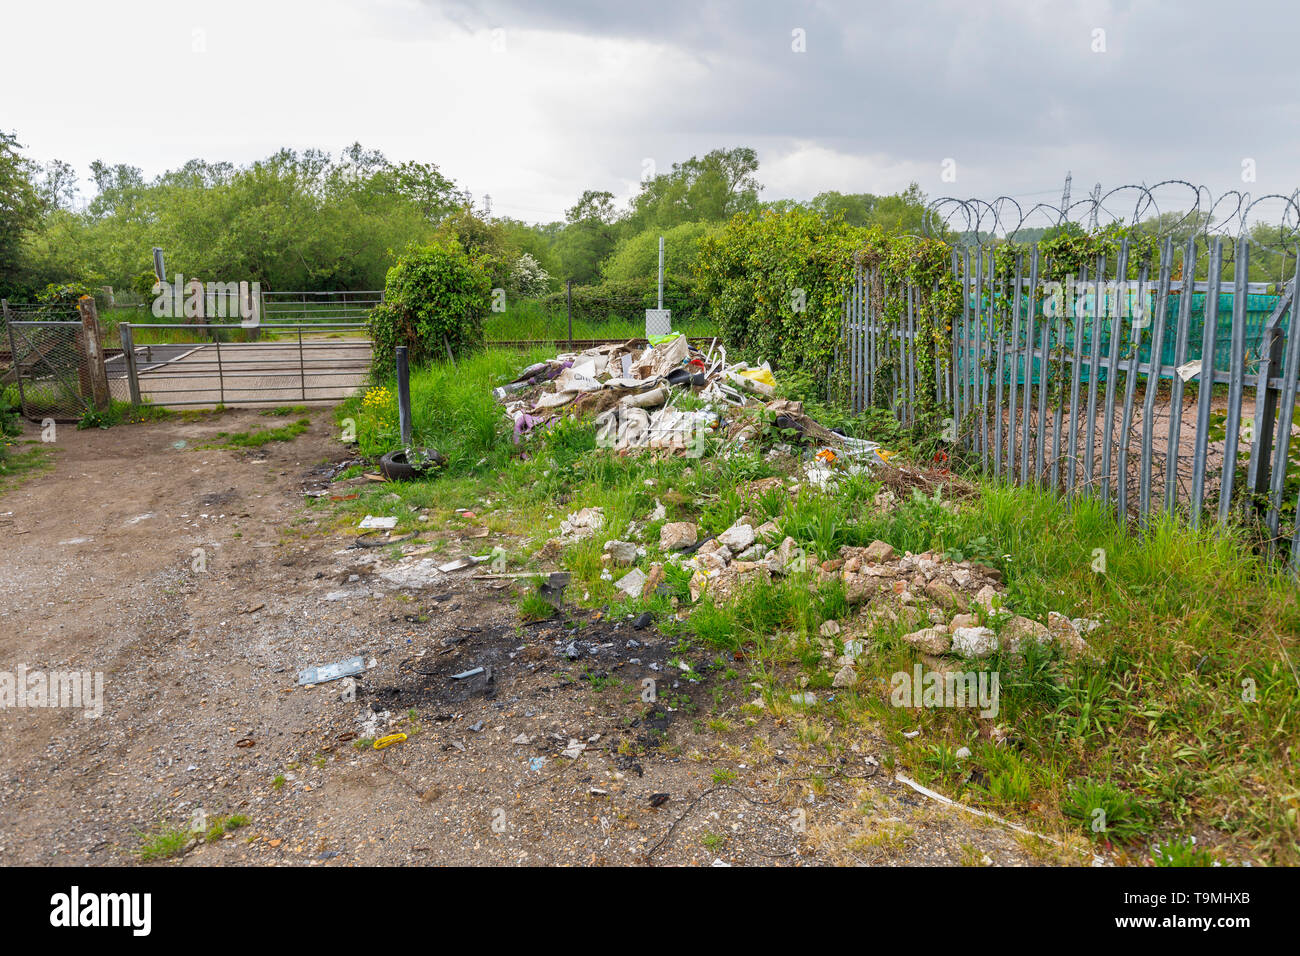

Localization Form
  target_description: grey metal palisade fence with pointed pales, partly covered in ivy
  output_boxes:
[839,237,1300,567]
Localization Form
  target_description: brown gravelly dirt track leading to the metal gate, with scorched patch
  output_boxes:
[0,410,1035,865]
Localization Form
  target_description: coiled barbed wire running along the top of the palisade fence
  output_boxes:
[922,179,1300,251]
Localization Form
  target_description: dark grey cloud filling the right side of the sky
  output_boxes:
[439,0,1300,208]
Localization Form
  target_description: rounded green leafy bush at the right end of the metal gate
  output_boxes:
[369,239,491,373]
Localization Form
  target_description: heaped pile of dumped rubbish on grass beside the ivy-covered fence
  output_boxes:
[493,332,889,468]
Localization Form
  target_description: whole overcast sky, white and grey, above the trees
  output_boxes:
[0,0,1300,221]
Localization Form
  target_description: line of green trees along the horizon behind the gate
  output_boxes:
[0,131,926,299]
